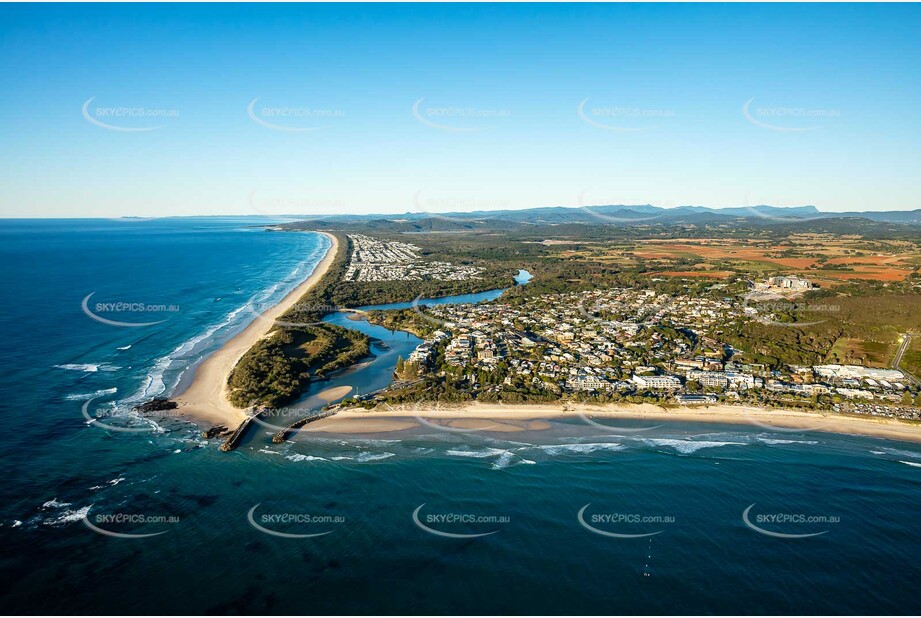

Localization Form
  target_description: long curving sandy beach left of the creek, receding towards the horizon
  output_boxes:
[171,232,339,429]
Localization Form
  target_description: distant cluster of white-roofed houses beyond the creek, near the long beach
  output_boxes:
[343,234,481,281]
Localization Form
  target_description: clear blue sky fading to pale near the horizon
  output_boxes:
[0,4,921,217]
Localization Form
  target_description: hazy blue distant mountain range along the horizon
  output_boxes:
[284,204,921,230]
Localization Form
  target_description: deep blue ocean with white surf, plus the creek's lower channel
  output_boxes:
[0,219,921,615]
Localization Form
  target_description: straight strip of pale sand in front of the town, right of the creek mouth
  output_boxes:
[301,402,921,443]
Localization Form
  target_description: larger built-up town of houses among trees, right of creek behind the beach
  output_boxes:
[390,282,921,420]
